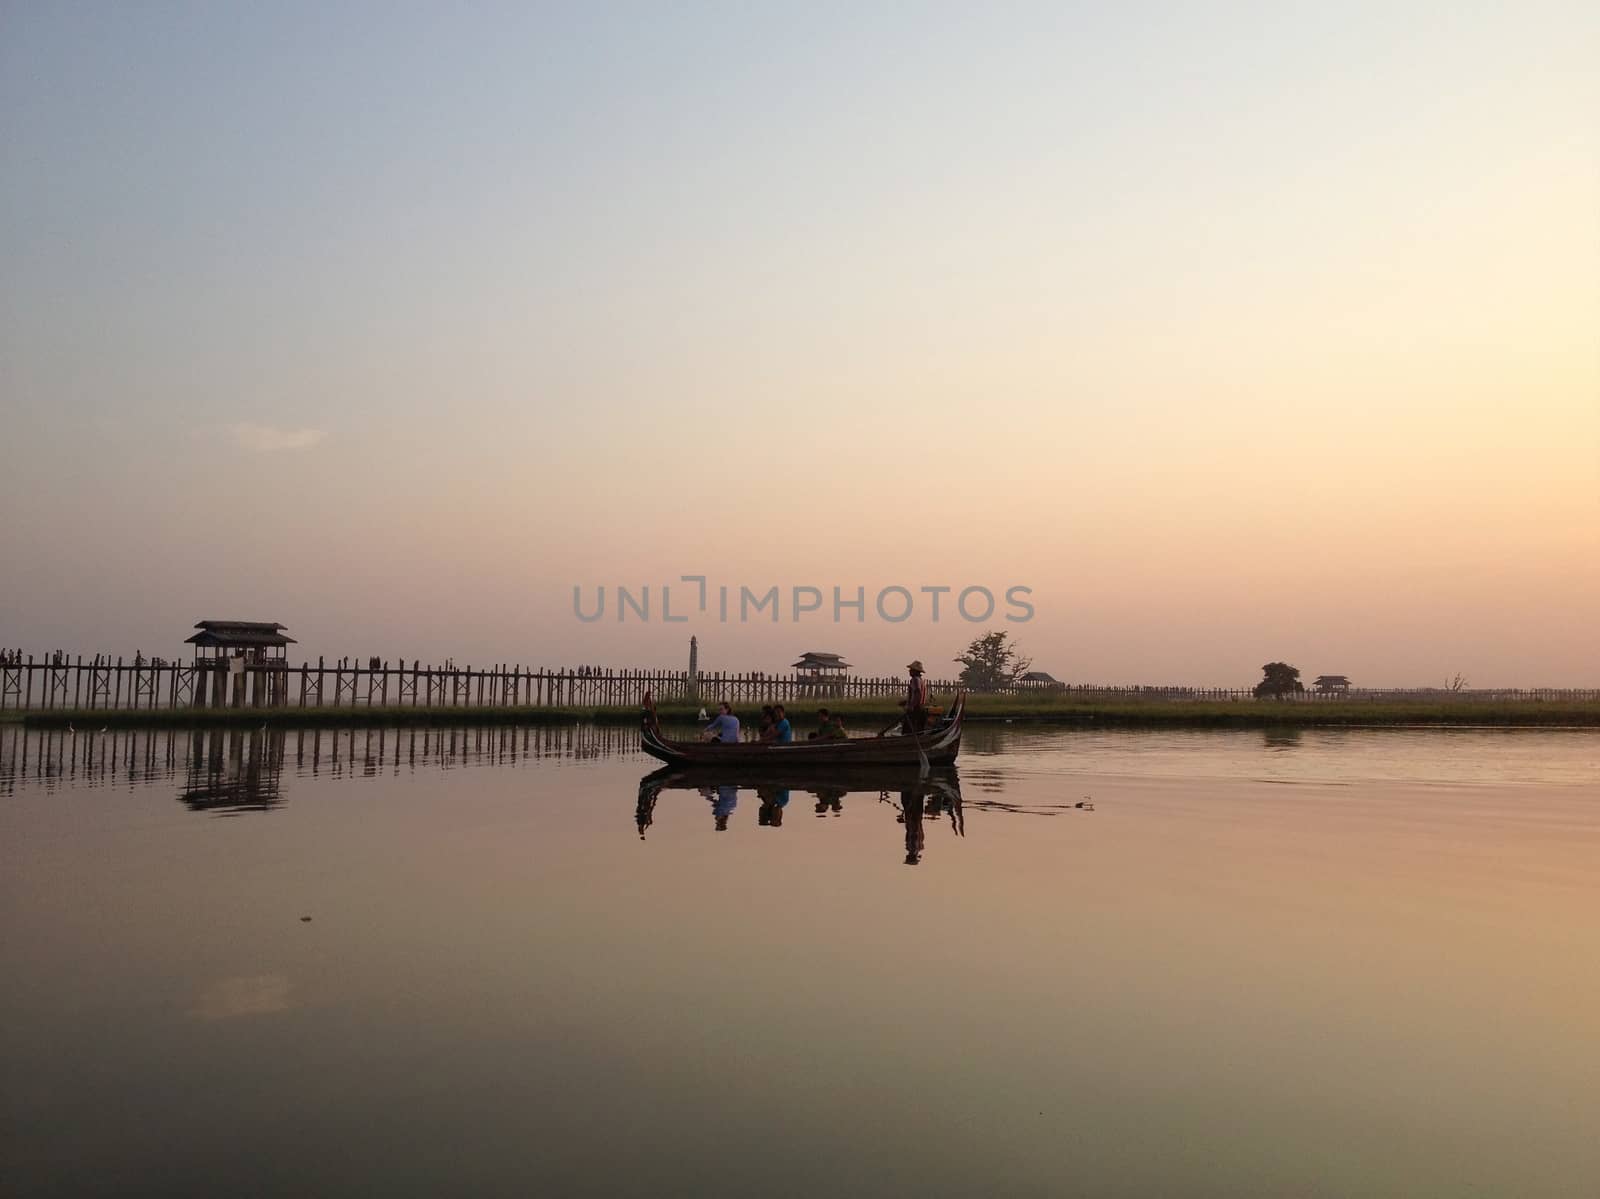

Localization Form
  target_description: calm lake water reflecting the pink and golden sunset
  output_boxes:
[0,725,1600,1199]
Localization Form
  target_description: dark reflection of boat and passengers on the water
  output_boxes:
[634,765,966,866]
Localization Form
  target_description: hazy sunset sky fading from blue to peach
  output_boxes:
[0,0,1600,687]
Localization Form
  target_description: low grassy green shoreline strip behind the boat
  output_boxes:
[3,695,1600,735]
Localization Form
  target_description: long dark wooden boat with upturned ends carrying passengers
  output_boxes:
[640,692,966,768]
